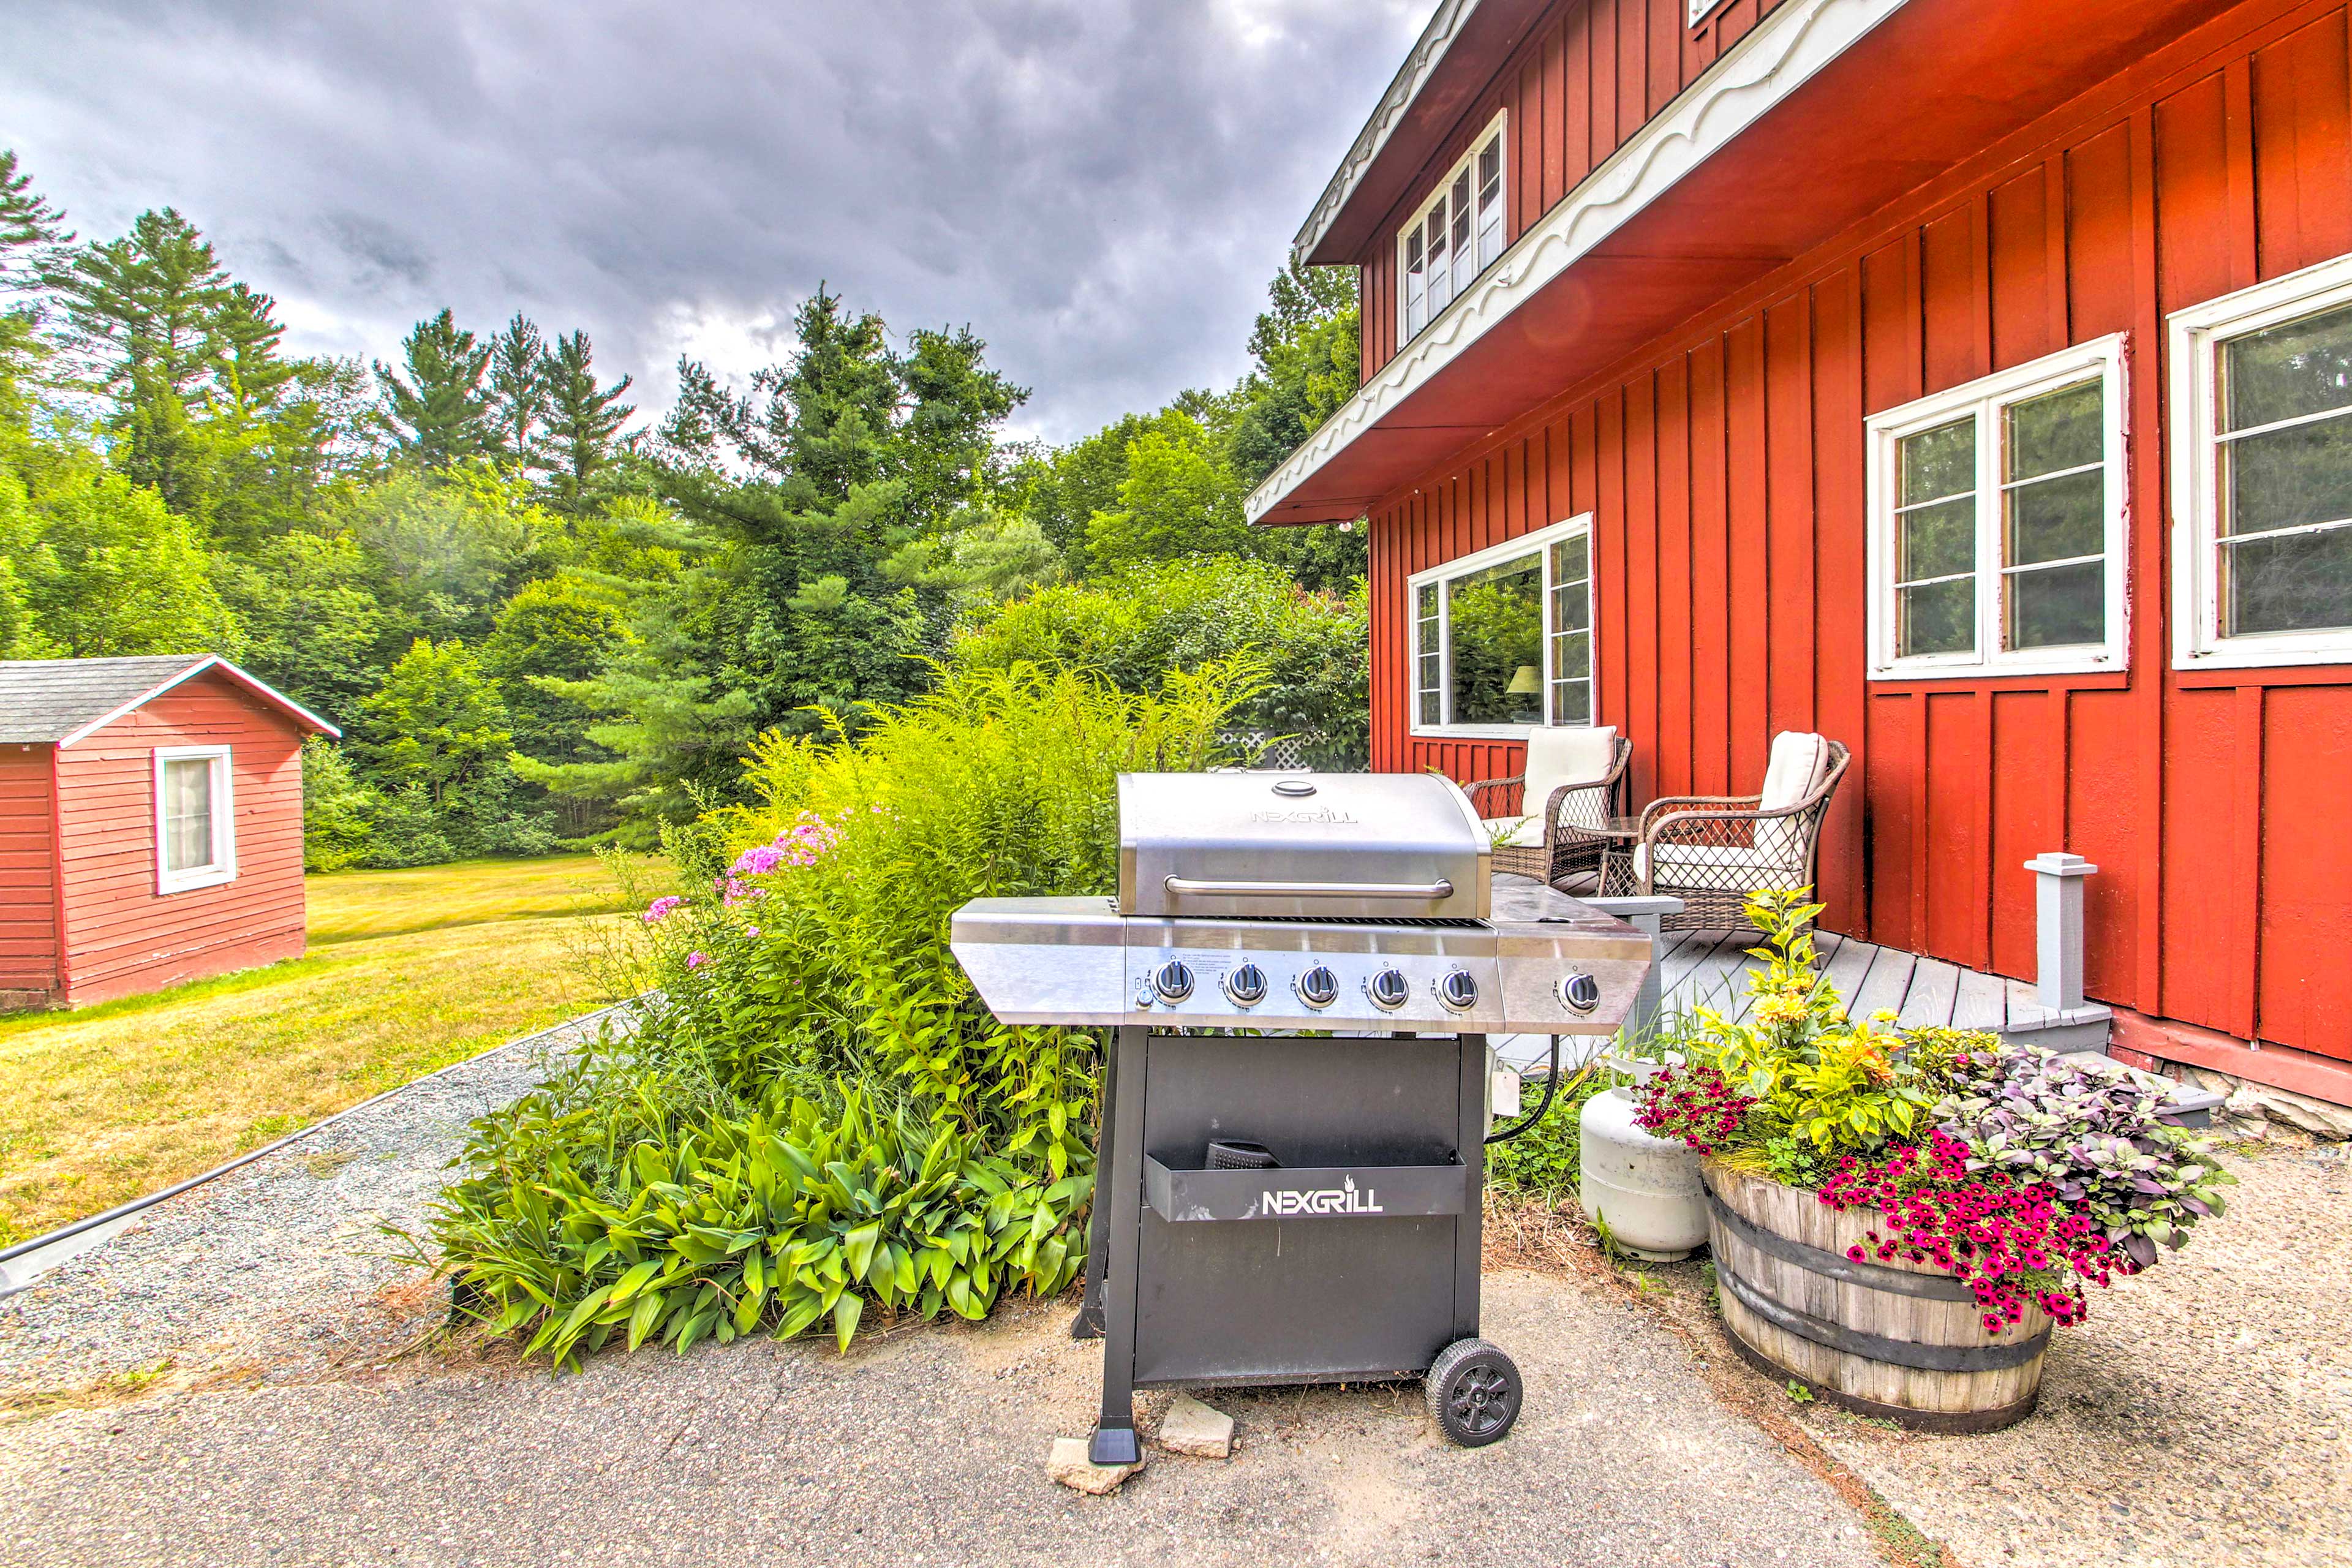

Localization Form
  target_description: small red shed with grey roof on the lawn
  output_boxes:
[0,654,341,1006]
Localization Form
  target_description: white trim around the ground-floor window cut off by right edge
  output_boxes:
[2168,256,2352,670]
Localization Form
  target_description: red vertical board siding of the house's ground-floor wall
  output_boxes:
[1366,0,2352,1060]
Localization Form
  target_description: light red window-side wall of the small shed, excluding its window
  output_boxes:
[54,675,303,1004]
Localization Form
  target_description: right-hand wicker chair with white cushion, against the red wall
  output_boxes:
[1602,733,1849,931]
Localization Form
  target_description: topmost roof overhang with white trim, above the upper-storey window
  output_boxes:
[1291,0,1550,266]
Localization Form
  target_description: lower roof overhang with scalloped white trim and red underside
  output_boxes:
[1246,0,2248,524]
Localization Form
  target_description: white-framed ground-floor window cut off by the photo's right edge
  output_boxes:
[2171,256,2352,670]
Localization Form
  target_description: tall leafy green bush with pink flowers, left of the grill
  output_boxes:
[431,665,1254,1363]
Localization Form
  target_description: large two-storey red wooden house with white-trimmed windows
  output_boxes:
[1249,0,2352,1100]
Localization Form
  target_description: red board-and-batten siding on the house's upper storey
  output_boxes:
[1357,0,1783,376]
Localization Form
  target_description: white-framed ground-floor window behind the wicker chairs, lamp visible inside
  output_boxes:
[1406,515,1597,738]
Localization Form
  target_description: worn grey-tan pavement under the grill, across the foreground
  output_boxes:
[0,1270,1879,1568]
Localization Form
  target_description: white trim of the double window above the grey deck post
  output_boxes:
[1865,334,2131,679]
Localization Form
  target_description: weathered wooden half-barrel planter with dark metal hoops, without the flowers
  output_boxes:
[1703,1159,2051,1431]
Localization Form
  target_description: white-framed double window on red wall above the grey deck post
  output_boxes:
[1868,336,2128,679]
